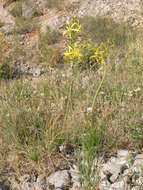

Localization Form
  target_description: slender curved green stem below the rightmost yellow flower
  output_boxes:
[91,64,106,129]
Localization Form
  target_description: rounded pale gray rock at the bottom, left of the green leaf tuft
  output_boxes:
[48,170,71,189]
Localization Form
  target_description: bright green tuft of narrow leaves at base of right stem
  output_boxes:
[79,121,107,190]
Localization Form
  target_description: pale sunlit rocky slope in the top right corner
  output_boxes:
[78,0,143,26]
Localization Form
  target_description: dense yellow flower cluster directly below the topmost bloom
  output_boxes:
[64,43,83,62]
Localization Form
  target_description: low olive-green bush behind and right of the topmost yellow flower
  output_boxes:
[81,16,135,48]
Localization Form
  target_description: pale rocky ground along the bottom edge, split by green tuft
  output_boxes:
[1,150,143,190]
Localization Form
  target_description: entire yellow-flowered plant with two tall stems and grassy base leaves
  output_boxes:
[64,19,107,189]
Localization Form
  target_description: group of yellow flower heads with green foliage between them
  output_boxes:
[63,19,108,69]
